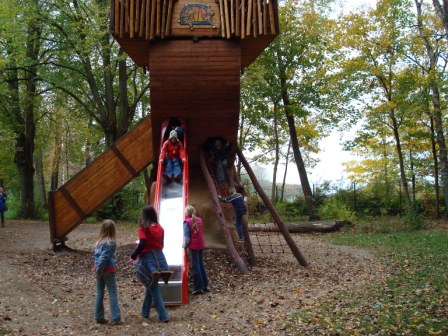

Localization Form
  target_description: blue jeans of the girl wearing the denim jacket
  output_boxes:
[94,272,121,320]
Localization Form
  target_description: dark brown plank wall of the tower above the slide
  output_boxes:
[149,39,241,164]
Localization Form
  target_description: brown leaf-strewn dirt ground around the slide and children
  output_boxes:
[0,221,388,336]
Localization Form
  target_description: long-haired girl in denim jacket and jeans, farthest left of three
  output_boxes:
[94,219,123,325]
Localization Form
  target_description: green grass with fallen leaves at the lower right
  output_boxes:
[289,223,448,335]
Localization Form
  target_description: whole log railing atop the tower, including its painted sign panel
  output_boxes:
[110,0,278,40]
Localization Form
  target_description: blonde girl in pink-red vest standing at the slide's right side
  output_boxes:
[183,205,209,295]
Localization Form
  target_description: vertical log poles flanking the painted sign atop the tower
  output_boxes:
[110,0,278,40]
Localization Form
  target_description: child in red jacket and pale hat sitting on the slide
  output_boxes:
[159,130,185,182]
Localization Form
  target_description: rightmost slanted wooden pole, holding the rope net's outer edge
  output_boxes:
[236,147,308,267]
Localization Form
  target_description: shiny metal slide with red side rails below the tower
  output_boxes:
[154,121,188,305]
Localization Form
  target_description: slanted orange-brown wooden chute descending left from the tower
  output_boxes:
[49,116,153,248]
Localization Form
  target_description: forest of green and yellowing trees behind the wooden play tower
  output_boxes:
[0,0,448,225]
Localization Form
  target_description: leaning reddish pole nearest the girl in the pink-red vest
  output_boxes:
[199,150,249,274]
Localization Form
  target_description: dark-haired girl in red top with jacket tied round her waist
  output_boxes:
[131,205,172,322]
